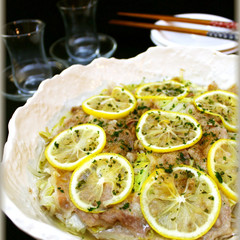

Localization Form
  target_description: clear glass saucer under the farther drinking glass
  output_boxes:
[49,33,117,66]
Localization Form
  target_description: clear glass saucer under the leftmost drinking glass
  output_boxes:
[2,58,67,102]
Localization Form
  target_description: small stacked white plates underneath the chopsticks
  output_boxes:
[150,13,238,54]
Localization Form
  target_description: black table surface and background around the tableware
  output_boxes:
[3,0,236,240]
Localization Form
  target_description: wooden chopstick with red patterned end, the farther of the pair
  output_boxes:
[117,12,237,29]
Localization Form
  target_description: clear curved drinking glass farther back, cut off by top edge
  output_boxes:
[57,0,99,64]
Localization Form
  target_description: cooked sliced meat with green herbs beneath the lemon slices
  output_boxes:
[38,83,237,240]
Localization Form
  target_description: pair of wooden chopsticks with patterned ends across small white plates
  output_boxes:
[109,12,238,41]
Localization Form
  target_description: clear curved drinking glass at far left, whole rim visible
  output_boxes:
[2,19,52,94]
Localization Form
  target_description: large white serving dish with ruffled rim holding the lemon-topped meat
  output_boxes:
[2,47,238,240]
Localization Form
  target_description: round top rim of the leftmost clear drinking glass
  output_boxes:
[1,19,46,38]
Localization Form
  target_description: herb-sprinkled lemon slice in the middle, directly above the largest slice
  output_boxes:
[136,110,202,152]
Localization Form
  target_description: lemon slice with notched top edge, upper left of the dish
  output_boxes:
[82,87,137,119]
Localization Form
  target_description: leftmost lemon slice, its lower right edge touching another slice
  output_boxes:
[45,124,106,171]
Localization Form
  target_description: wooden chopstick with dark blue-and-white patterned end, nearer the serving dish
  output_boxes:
[109,19,238,41]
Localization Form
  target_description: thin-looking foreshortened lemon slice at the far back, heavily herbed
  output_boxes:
[135,80,189,99]
